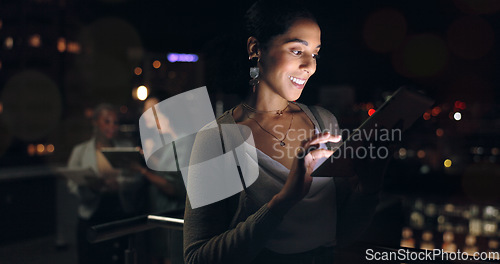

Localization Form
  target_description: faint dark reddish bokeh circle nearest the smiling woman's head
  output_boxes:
[363,8,407,52]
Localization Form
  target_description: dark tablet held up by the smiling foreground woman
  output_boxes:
[311,87,434,177]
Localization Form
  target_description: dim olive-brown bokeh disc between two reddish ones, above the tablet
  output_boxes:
[392,34,448,78]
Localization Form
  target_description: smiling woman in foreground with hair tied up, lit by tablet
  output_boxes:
[184,1,378,264]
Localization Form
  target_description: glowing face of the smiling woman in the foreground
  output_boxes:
[259,19,321,101]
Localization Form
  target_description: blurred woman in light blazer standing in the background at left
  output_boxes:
[68,104,140,264]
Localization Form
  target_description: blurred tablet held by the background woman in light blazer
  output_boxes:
[101,147,145,169]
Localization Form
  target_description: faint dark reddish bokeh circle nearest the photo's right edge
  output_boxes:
[447,16,494,59]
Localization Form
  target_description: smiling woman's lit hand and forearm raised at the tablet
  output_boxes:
[268,133,342,212]
